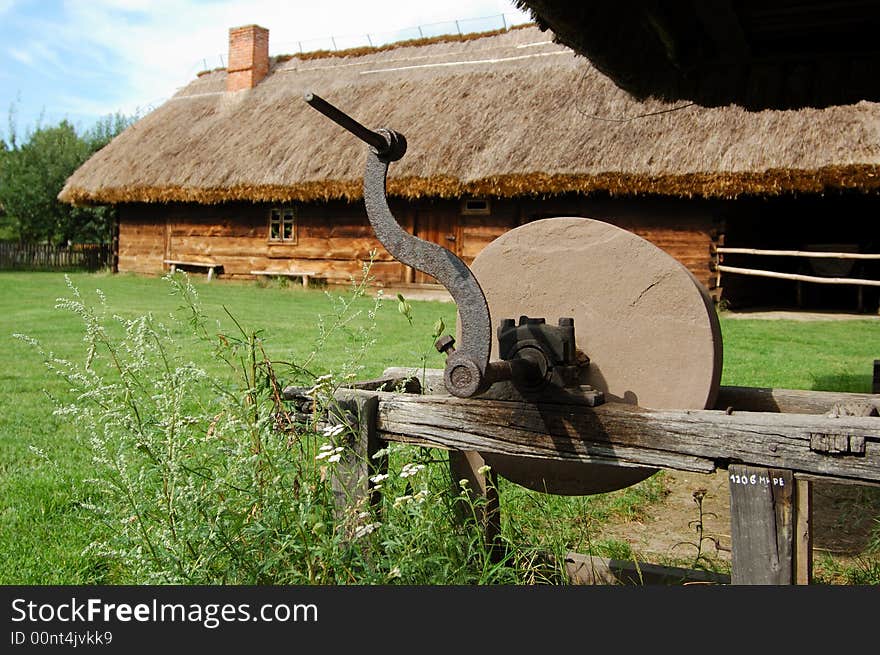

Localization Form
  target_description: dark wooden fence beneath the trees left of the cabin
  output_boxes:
[0,242,113,271]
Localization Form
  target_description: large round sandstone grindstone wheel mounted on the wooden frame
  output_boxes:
[471,217,722,495]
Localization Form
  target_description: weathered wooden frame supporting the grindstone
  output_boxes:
[294,368,880,585]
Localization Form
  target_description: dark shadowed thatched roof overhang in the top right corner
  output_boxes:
[516,0,880,110]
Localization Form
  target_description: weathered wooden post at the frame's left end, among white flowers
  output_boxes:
[328,391,388,514]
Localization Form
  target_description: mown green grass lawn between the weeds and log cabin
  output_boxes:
[0,273,880,584]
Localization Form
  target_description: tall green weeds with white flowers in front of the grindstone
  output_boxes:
[21,267,546,584]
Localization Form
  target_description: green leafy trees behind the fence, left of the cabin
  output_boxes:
[0,114,133,244]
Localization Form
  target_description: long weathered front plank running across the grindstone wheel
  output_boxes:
[368,394,880,482]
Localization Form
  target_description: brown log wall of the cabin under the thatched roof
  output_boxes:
[119,194,718,288]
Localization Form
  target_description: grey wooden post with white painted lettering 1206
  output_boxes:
[728,464,795,585]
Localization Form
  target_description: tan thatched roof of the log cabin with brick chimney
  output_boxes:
[60,27,880,203]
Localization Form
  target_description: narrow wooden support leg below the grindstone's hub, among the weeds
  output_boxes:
[449,450,504,562]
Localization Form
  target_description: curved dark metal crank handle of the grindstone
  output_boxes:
[304,93,496,398]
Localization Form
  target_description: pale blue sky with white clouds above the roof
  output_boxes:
[0,0,530,141]
